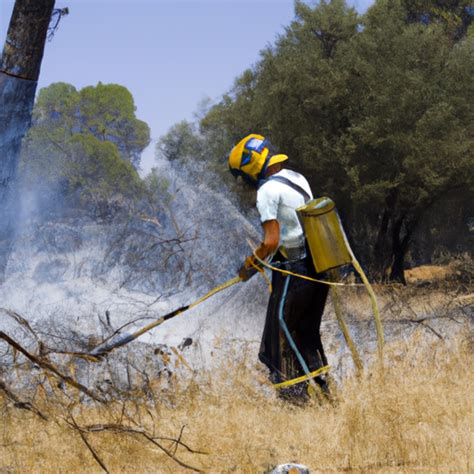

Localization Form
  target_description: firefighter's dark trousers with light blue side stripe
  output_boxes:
[259,256,329,383]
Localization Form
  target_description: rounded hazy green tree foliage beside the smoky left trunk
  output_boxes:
[20,83,149,215]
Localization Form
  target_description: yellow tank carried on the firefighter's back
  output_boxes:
[296,197,352,273]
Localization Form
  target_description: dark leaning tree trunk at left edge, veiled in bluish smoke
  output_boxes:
[0,0,55,280]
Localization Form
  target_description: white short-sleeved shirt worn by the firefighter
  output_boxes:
[257,169,313,248]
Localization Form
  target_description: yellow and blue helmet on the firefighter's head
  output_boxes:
[229,133,288,184]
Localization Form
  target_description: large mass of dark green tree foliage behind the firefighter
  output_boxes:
[161,0,474,280]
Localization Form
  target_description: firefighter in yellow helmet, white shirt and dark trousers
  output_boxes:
[229,134,328,398]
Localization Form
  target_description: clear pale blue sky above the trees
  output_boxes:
[0,0,373,173]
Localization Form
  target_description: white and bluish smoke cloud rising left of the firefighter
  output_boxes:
[0,139,267,368]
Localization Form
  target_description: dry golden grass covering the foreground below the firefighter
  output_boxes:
[0,330,474,473]
